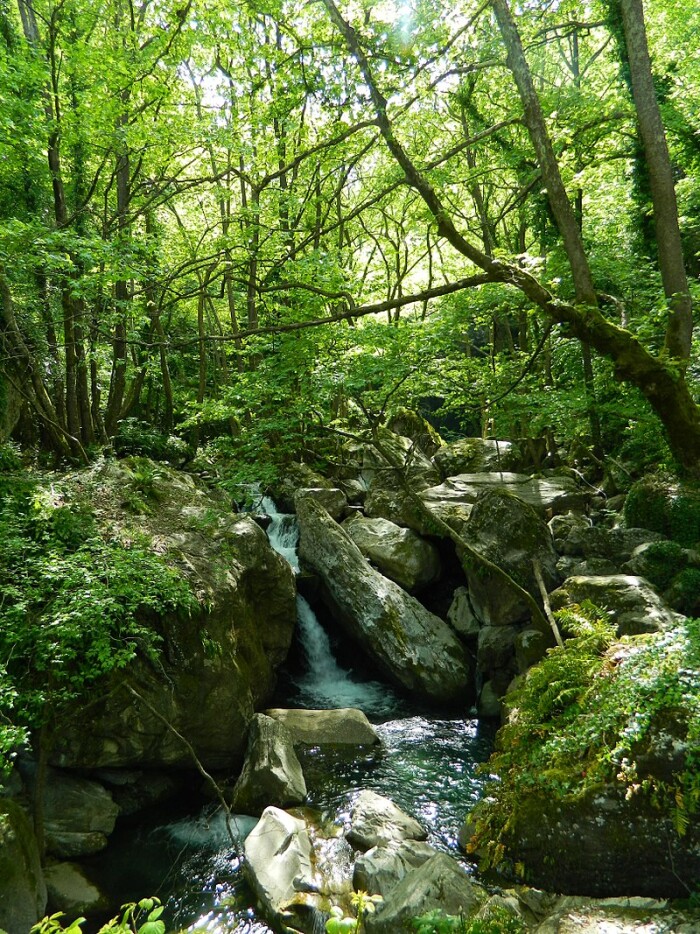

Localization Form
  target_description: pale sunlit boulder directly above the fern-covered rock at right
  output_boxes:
[550,574,681,636]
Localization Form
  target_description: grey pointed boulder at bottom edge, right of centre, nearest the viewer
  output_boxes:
[365,853,488,934]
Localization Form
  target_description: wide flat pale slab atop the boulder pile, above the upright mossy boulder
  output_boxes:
[420,471,587,514]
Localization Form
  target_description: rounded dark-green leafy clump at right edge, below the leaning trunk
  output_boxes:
[623,477,700,548]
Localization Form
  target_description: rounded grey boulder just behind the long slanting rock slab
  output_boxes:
[343,516,440,593]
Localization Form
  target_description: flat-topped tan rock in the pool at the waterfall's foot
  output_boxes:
[265,707,380,746]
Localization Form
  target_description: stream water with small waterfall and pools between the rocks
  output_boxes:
[80,498,495,934]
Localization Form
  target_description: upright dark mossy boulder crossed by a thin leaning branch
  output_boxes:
[463,490,559,626]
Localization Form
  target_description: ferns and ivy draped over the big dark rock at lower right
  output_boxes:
[471,604,700,865]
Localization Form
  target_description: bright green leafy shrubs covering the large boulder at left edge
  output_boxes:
[0,477,194,761]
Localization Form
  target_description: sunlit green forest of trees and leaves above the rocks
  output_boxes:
[0,0,700,474]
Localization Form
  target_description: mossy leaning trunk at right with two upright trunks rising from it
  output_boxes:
[323,0,700,474]
